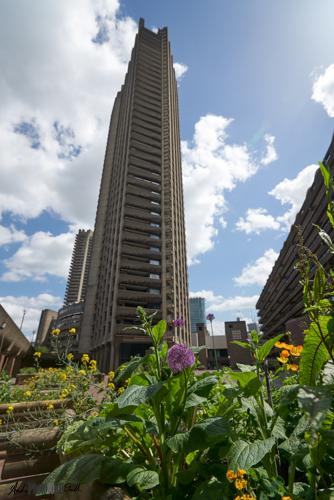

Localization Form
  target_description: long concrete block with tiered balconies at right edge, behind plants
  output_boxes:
[256,137,334,338]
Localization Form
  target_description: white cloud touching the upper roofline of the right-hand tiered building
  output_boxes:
[269,165,318,231]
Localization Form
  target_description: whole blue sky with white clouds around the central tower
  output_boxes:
[0,0,334,338]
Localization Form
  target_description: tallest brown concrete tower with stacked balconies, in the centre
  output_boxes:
[79,19,191,371]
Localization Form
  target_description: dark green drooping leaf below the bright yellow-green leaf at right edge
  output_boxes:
[298,387,332,447]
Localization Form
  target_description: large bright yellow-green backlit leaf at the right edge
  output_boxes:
[299,316,334,386]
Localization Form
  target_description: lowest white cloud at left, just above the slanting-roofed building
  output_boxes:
[0,293,62,340]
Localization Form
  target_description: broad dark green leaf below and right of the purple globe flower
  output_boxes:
[166,417,232,453]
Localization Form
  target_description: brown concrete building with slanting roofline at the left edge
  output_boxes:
[0,304,34,375]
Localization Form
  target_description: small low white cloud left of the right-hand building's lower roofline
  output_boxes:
[233,248,279,286]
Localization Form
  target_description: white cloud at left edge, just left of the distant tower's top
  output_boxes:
[1,231,75,281]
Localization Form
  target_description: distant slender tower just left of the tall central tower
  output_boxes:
[64,229,93,306]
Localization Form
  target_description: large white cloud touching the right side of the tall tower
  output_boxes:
[181,115,278,264]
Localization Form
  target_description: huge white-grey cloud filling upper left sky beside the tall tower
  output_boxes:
[0,0,138,228]
